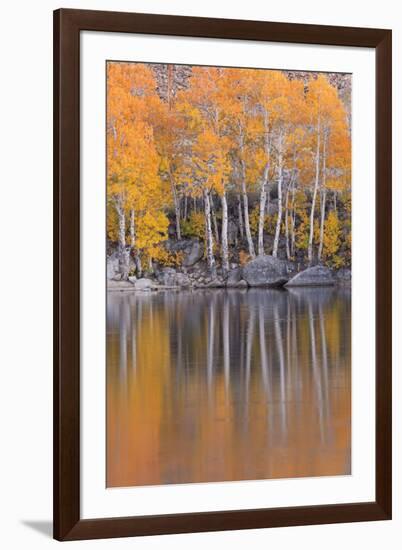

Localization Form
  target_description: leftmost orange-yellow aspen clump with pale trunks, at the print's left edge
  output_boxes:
[107,63,167,279]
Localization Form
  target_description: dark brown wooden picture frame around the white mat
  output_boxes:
[53,9,392,540]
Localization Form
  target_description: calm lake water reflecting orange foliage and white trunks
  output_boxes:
[107,288,351,487]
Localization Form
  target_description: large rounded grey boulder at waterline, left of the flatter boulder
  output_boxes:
[243,256,289,287]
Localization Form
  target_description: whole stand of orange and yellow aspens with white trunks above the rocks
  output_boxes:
[107,62,351,278]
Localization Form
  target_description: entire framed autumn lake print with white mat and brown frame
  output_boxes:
[54,9,392,540]
